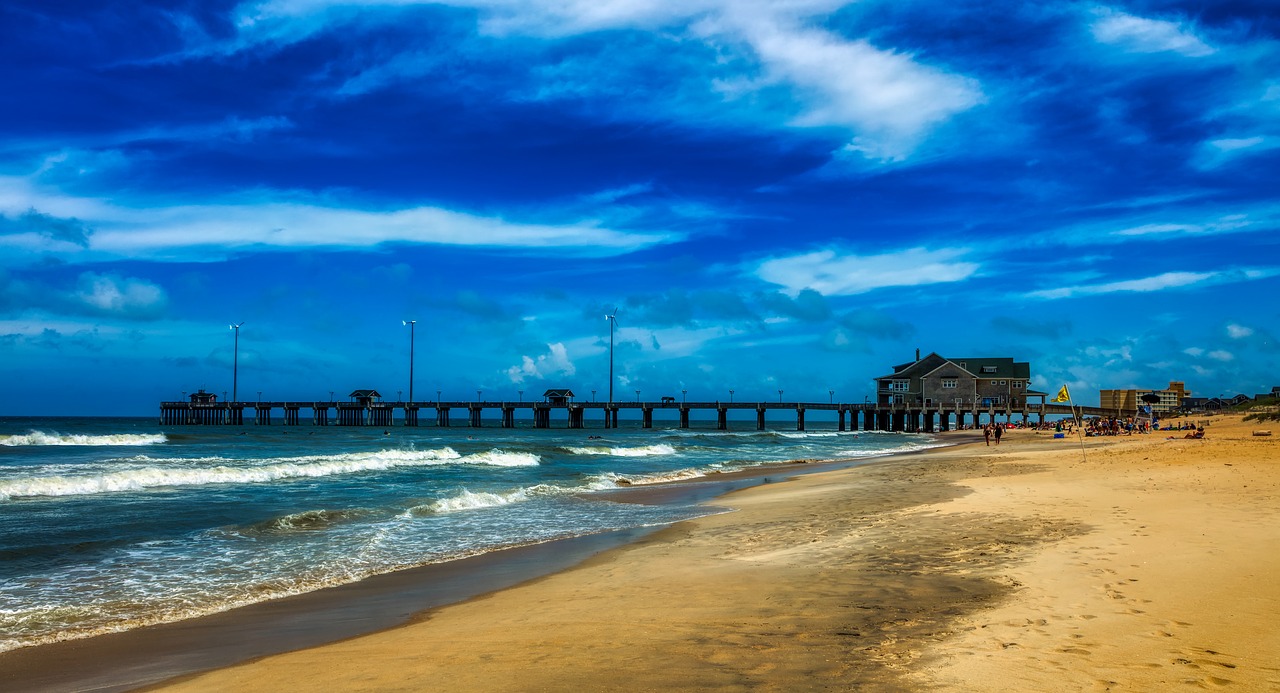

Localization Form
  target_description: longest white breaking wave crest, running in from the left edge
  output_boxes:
[0,447,538,501]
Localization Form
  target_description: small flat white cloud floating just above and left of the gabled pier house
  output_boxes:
[754,247,979,296]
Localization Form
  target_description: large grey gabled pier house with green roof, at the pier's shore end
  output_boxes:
[876,352,1044,409]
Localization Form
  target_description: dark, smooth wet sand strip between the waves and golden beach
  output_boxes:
[0,432,963,692]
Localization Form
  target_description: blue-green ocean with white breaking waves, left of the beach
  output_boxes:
[0,418,938,652]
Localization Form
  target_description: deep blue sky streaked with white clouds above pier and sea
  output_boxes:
[0,0,1280,416]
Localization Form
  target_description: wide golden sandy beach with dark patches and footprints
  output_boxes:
[152,418,1280,692]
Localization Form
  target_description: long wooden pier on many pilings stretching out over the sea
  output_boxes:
[160,398,1090,433]
